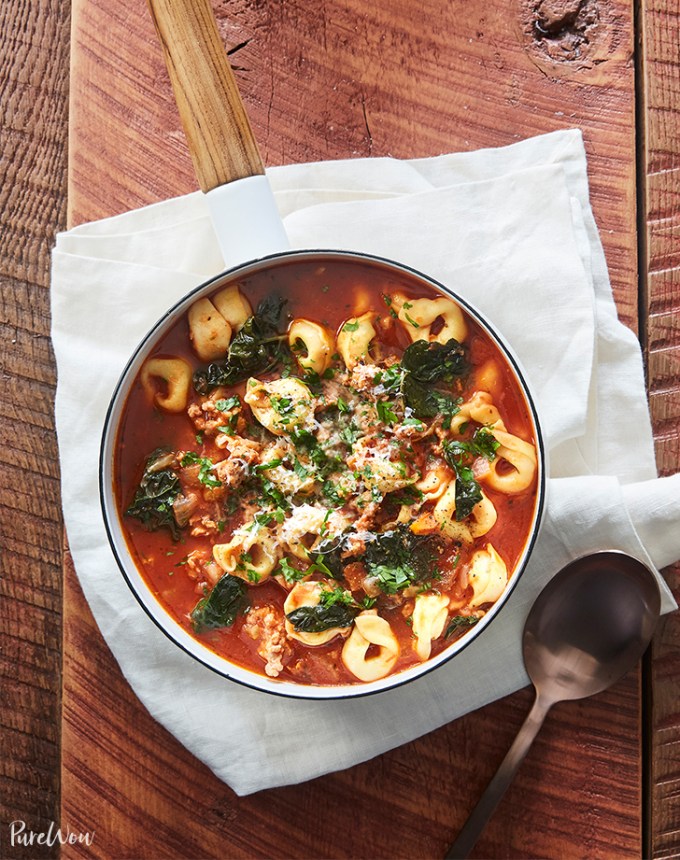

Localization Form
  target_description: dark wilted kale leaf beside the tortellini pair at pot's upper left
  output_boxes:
[194,295,288,395]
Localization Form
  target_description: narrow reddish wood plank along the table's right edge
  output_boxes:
[640,0,680,860]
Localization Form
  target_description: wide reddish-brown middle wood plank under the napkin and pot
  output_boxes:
[62,0,641,858]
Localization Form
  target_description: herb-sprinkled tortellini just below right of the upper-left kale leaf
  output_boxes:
[243,376,314,436]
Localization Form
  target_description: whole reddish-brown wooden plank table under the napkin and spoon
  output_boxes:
[0,0,680,860]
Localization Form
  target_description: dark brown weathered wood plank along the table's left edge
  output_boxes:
[0,0,69,858]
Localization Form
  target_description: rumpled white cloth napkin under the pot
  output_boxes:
[52,131,680,794]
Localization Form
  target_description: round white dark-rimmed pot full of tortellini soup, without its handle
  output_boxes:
[100,252,546,698]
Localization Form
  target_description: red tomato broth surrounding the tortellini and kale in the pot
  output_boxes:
[114,259,537,685]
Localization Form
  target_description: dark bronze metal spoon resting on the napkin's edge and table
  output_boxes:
[446,550,661,858]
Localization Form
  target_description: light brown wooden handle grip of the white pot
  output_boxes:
[148,0,264,192]
